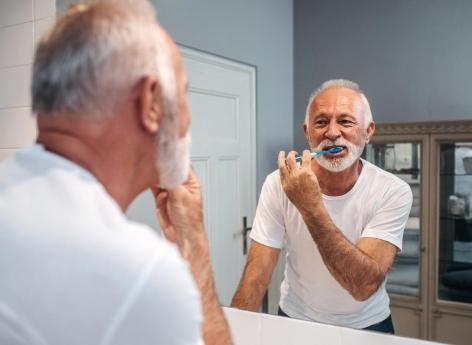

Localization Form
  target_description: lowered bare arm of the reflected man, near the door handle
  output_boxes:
[231,241,280,311]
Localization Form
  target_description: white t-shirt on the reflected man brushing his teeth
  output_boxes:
[251,160,413,328]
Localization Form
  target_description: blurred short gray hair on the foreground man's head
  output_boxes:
[32,0,177,118]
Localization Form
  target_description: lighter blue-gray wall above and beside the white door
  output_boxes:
[57,0,293,191]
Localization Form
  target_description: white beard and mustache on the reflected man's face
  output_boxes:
[315,138,365,172]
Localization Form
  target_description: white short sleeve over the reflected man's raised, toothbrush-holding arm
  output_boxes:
[361,181,413,251]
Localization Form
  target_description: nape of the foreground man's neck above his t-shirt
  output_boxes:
[37,124,151,211]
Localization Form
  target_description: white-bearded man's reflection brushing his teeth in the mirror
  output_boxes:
[232,80,412,333]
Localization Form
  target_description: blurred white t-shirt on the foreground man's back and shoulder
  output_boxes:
[0,145,202,345]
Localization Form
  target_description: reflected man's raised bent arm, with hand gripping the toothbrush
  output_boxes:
[279,151,404,301]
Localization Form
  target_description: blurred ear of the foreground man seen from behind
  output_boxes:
[136,76,164,134]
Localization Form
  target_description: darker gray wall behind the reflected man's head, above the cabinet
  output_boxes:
[294,0,472,149]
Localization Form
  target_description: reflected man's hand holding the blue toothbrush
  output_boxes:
[278,150,321,214]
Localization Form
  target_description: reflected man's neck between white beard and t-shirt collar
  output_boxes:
[311,159,362,196]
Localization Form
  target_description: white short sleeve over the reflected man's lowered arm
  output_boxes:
[250,171,285,248]
